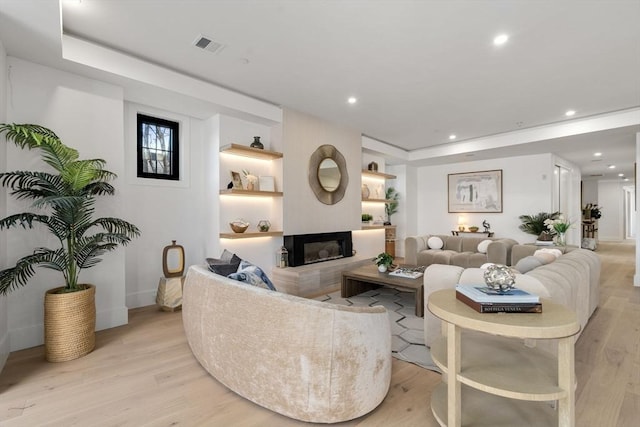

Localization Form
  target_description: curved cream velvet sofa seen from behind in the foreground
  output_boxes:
[182,266,391,423]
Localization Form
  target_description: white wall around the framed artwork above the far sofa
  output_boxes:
[416,154,560,243]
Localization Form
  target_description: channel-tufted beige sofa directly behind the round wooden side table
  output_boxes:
[423,245,601,349]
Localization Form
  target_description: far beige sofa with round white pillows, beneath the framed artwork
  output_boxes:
[404,234,518,268]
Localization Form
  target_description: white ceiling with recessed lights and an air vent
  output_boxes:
[0,0,640,178]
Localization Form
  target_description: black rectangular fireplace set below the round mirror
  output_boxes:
[284,231,353,267]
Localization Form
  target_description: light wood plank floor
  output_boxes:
[0,244,640,427]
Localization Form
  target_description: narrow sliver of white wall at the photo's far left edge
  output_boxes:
[0,41,9,372]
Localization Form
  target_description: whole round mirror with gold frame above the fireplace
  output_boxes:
[309,145,349,205]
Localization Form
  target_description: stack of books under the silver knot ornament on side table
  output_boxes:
[456,285,542,313]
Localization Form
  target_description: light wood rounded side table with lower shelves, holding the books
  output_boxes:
[427,289,580,427]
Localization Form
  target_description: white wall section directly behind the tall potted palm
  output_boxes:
[3,57,130,351]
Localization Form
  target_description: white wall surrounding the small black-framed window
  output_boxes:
[122,102,207,308]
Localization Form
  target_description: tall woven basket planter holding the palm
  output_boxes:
[44,285,96,362]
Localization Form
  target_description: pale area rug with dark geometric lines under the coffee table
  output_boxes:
[316,287,440,372]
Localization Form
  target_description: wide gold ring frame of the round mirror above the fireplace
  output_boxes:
[309,144,349,205]
